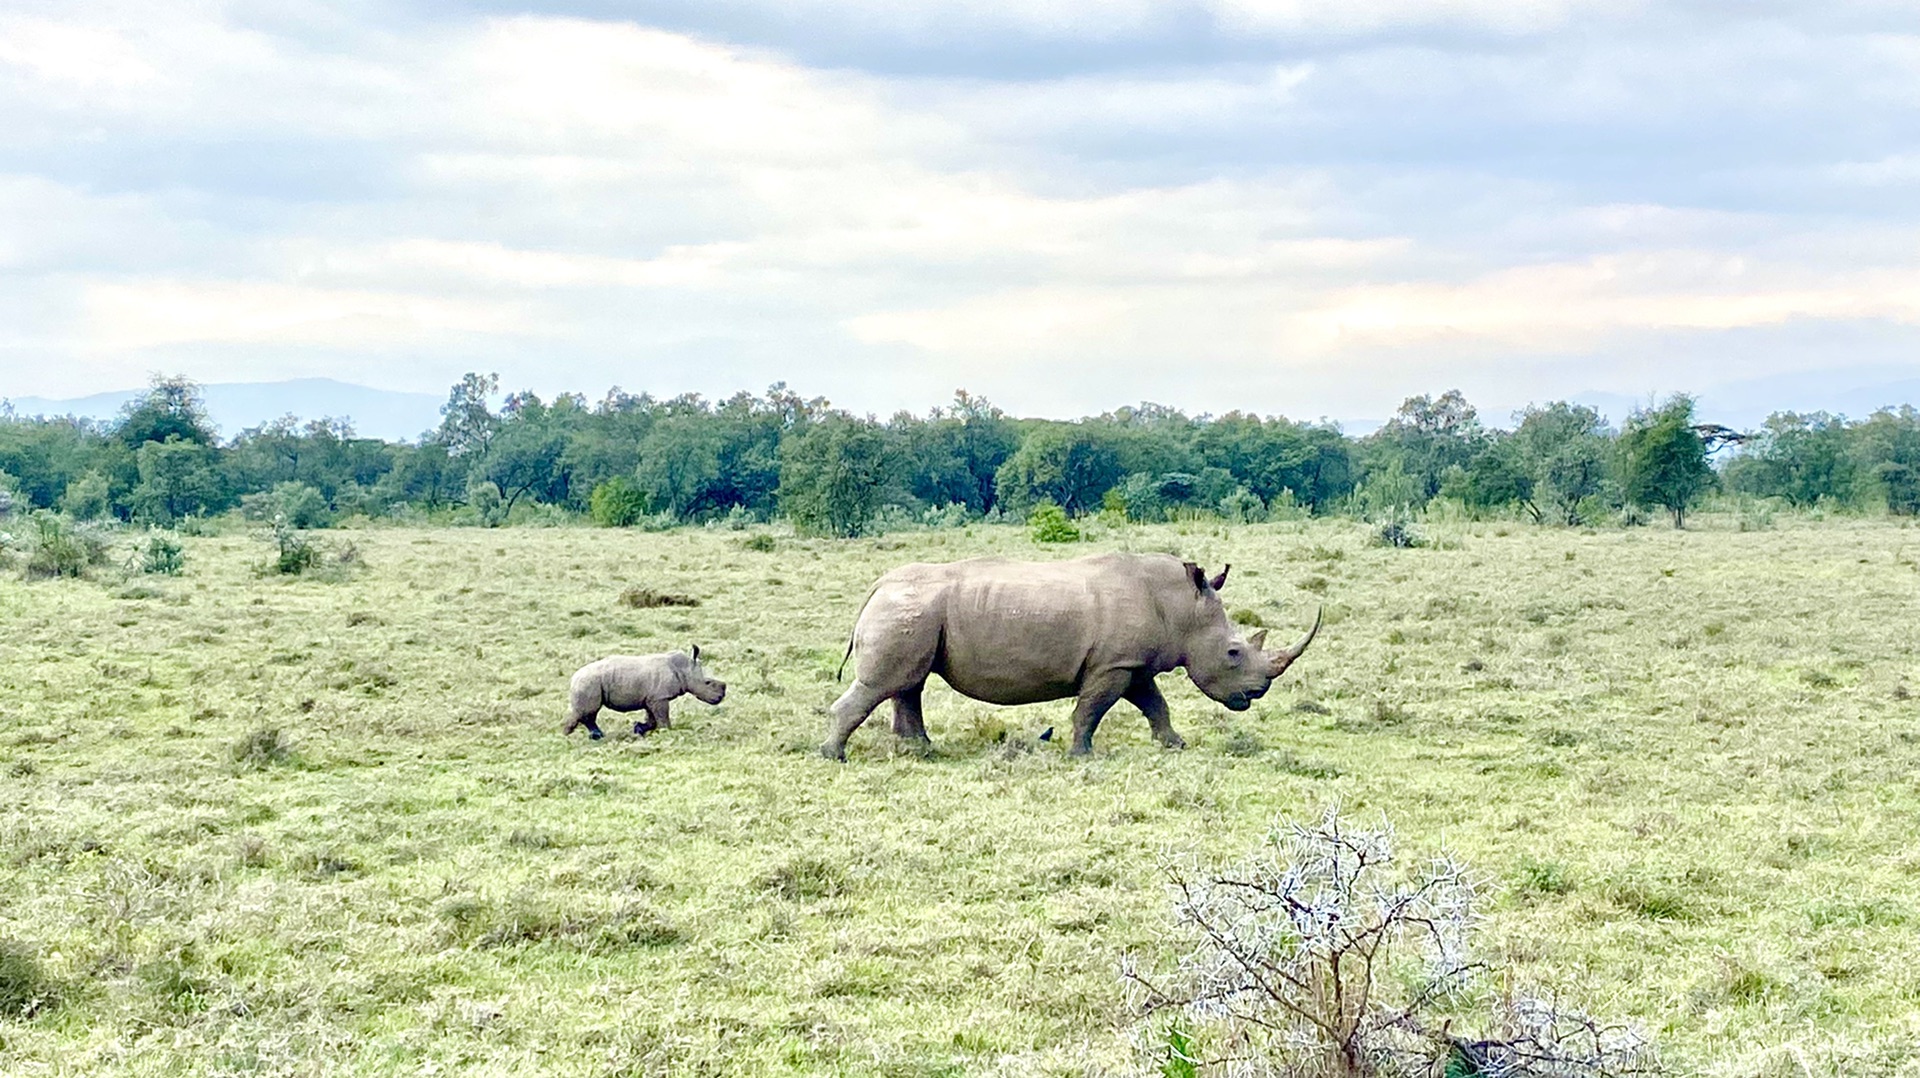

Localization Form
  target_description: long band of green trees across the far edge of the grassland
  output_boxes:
[0,375,1920,536]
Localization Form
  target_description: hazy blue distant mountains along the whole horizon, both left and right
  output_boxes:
[0,363,1920,442]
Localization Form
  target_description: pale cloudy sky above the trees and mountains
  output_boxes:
[0,0,1920,419]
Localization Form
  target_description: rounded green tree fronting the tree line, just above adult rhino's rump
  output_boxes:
[780,413,887,536]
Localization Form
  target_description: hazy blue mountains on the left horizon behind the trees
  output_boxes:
[1,379,445,442]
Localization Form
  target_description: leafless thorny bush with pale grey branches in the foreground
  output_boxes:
[1121,809,1657,1078]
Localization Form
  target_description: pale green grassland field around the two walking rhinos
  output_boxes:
[0,515,1920,1076]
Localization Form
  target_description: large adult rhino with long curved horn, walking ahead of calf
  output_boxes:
[820,553,1319,759]
